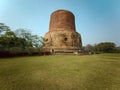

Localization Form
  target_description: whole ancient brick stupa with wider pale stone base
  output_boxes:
[44,10,82,53]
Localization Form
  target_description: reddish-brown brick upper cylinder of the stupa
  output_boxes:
[49,10,75,31]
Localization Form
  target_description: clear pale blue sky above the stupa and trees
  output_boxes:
[0,0,120,46]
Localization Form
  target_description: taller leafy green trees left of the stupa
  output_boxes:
[0,23,47,57]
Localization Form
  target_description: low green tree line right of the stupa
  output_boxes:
[83,42,120,54]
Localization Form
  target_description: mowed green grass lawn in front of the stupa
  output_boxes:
[0,54,120,90]
